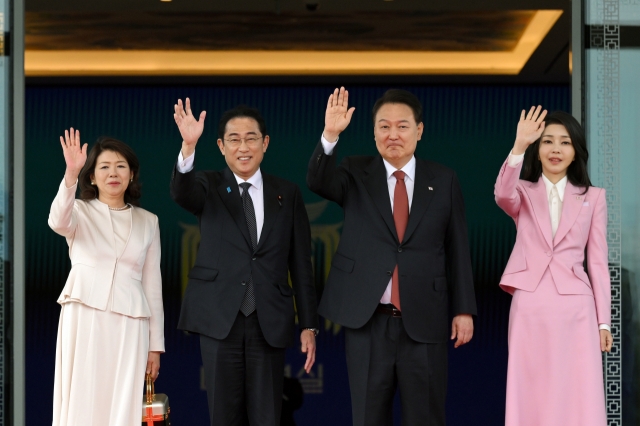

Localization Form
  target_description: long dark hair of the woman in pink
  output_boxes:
[521,111,593,194]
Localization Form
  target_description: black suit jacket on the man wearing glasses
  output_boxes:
[171,167,318,347]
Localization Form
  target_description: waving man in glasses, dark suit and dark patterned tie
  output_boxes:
[171,98,318,426]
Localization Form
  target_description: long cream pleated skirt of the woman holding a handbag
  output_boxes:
[53,302,149,426]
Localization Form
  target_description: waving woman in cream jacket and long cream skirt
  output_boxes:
[49,128,164,426]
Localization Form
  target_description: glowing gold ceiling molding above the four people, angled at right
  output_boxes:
[25,10,562,77]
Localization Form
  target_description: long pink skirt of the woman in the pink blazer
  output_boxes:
[505,269,607,426]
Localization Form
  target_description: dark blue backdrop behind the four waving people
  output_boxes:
[26,85,570,426]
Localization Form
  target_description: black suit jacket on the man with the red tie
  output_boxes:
[307,143,476,343]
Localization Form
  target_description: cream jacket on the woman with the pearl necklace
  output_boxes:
[49,179,164,352]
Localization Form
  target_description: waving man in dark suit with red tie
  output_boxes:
[307,87,476,426]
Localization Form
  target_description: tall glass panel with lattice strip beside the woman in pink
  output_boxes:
[585,0,640,426]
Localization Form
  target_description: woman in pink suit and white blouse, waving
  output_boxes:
[495,106,613,426]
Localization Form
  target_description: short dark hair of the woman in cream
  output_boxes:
[78,136,142,206]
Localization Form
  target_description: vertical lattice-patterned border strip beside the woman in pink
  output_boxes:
[589,0,620,426]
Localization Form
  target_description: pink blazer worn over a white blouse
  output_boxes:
[494,161,611,324]
